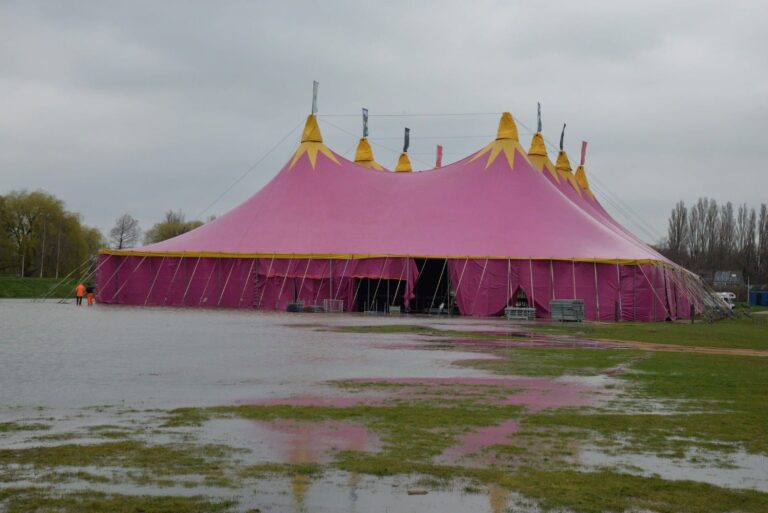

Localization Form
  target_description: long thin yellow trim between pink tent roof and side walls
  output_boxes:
[99,249,677,268]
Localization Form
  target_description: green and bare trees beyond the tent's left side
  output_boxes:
[0,190,207,278]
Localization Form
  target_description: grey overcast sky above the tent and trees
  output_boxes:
[0,0,768,240]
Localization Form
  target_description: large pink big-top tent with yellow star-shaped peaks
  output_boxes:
[97,105,704,320]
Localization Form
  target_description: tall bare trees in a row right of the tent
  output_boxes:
[660,198,768,283]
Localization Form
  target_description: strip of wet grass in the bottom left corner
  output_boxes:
[0,488,235,513]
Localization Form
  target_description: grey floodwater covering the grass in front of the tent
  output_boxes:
[0,300,768,513]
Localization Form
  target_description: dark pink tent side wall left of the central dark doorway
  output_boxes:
[96,255,417,310]
